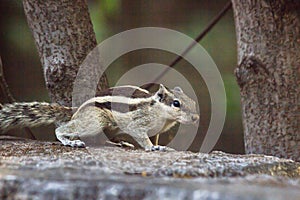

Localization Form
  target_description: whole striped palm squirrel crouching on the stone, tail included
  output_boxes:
[0,84,199,151]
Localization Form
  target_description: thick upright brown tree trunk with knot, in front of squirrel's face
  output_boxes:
[232,0,300,161]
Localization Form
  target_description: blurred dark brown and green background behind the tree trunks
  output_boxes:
[0,0,244,153]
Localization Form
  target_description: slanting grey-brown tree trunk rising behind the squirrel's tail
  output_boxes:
[23,0,108,106]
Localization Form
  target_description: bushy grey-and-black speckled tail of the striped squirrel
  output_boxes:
[0,102,72,133]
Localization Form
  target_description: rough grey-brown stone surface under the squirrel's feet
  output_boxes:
[0,136,300,199]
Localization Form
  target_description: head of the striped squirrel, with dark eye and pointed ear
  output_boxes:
[154,84,199,124]
